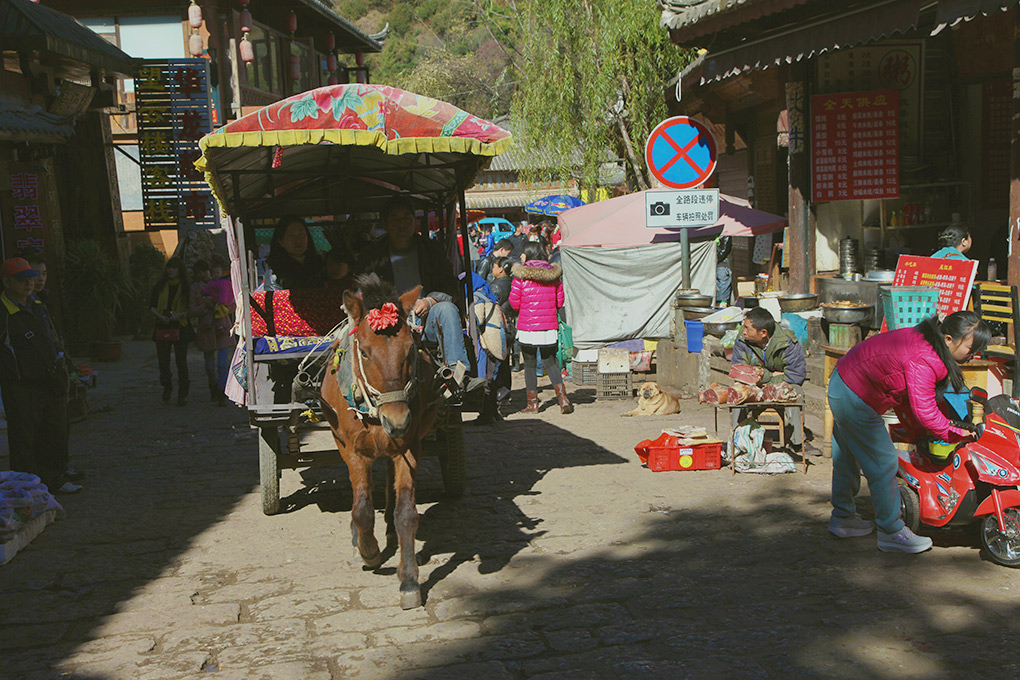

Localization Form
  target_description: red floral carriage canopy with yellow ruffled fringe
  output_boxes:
[195,84,512,217]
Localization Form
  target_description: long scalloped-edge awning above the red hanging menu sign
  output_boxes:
[701,0,922,84]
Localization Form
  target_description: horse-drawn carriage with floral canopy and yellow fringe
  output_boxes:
[197,85,511,515]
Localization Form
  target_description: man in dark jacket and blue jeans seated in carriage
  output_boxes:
[355,198,485,391]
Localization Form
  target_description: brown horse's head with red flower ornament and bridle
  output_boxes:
[344,277,421,439]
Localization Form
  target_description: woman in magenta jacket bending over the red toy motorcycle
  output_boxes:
[828,312,991,553]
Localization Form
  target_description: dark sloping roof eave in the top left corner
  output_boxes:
[0,0,137,76]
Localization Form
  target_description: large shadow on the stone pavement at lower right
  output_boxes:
[369,492,1020,680]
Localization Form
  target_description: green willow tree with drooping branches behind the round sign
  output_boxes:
[513,0,690,189]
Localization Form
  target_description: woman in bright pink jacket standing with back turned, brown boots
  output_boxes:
[510,243,573,413]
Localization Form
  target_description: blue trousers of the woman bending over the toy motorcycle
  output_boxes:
[828,369,903,533]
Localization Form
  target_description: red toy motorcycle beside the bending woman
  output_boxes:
[894,387,1020,567]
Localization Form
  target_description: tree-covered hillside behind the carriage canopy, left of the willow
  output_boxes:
[334,0,516,118]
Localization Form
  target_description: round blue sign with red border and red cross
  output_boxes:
[645,115,716,189]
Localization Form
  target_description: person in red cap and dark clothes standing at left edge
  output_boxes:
[0,257,82,492]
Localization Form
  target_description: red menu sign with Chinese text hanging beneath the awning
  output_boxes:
[810,90,900,201]
